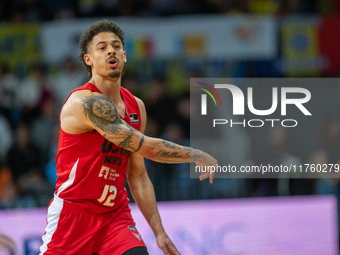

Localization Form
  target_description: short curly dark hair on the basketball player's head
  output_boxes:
[79,19,125,79]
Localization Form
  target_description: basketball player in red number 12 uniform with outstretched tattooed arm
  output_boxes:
[40,20,217,255]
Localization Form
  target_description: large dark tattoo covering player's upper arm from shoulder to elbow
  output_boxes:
[81,95,144,151]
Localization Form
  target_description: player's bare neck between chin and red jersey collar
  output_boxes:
[89,76,122,105]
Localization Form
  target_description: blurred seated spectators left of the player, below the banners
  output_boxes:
[0,58,86,208]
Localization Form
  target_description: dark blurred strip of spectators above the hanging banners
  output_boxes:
[0,0,339,22]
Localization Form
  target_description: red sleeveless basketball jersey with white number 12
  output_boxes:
[55,83,141,213]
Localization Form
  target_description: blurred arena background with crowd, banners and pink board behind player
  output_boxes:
[0,0,340,255]
